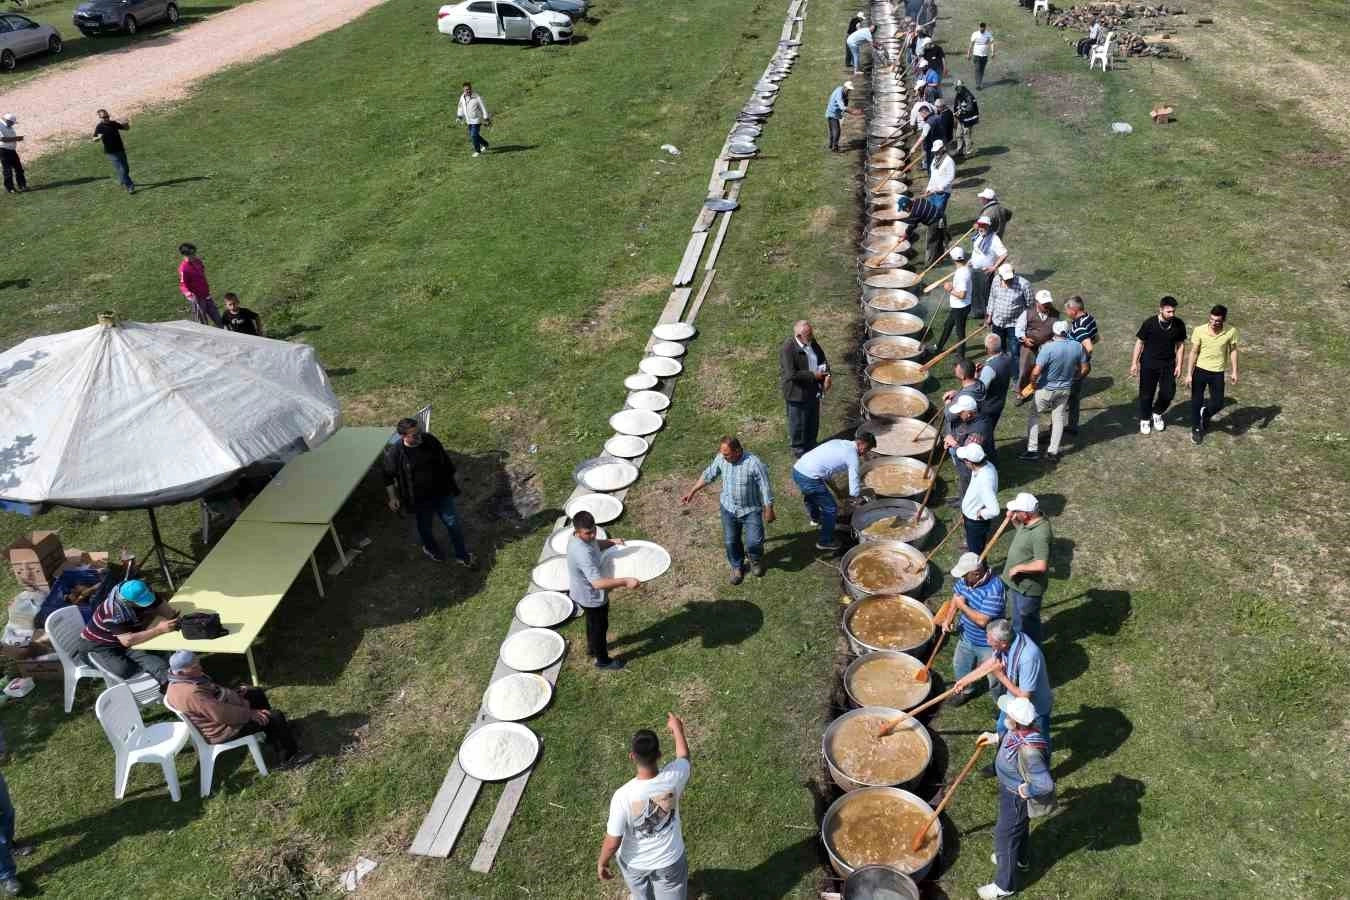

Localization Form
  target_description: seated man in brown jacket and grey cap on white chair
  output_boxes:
[165,650,315,769]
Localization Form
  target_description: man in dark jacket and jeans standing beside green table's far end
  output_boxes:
[385,418,474,568]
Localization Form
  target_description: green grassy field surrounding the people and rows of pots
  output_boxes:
[0,0,1350,897]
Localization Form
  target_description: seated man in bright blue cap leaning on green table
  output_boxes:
[76,579,180,690]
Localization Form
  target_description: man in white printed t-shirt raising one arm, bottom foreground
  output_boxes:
[595,712,690,900]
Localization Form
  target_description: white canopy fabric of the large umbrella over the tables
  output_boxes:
[0,321,342,509]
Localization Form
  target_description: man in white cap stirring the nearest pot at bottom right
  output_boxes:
[976,695,1054,900]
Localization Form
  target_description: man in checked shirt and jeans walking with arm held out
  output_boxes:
[680,436,774,584]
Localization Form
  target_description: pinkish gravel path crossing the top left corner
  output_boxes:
[0,0,383,159]
